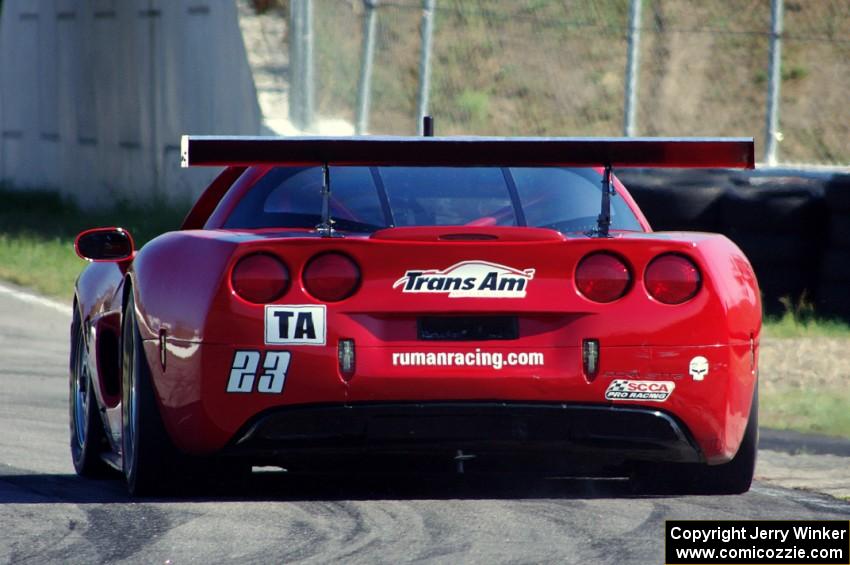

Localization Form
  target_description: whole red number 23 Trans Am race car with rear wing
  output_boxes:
[70,137,761,495]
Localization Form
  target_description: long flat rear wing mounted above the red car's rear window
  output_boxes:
[180,135,755,169]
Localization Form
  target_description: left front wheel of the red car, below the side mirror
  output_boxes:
[68,306,109,478]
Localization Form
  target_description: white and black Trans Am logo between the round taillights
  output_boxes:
[393,261,534,298]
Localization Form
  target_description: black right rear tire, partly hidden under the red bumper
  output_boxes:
[633,386,758,494]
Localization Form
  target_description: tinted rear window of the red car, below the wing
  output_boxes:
[224,167,641,233]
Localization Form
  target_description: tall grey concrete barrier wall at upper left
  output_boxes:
[0,0,261,207]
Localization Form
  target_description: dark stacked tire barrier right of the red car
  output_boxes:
[619,170,850,319]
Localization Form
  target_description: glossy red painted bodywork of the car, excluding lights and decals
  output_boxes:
[77,162,761,463]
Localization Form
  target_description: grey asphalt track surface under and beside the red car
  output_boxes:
[0,287,850,564]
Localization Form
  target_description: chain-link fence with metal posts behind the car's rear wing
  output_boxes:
[286,0,850,165]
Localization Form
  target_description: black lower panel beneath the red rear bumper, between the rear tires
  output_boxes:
[223,402,704,464]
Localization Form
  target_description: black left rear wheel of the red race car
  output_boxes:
[121,293,179,496]
